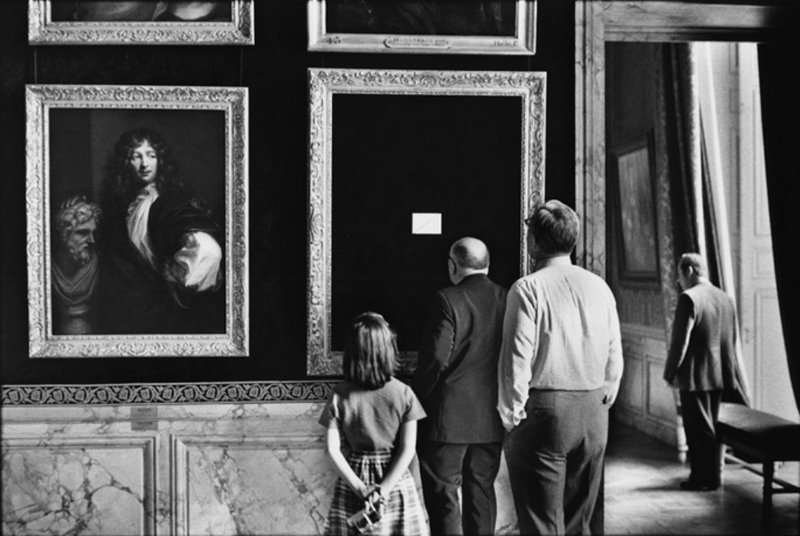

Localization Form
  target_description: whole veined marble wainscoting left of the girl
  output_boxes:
[0,401,336,536]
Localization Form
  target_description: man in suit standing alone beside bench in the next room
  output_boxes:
[664,253,747,491]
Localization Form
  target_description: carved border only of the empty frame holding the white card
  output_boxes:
[306,68,546,376]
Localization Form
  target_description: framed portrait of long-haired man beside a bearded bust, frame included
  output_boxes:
[26,85,249,358]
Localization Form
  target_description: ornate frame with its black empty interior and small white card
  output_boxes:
[306,69,546,376]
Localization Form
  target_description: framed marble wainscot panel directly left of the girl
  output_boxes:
[173,436,335,536]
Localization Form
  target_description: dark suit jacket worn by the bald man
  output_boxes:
[413,274,508,443]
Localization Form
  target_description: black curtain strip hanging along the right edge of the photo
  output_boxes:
[758,45,800,409]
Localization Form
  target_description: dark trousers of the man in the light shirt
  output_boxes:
[506,389,608,534]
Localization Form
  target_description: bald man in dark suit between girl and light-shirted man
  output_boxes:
[413,237,506,535]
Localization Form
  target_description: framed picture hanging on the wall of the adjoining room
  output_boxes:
[611,133,660,286]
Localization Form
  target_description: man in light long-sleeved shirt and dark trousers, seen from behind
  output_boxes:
[497,200,622,534]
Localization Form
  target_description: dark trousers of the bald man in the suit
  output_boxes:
[418,441,503,536]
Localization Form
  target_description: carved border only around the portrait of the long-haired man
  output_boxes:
[25,85,249,358]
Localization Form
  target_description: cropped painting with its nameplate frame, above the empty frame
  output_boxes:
[307,0,536,55]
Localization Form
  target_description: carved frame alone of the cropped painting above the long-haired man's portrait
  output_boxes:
[28,0,255,45]
